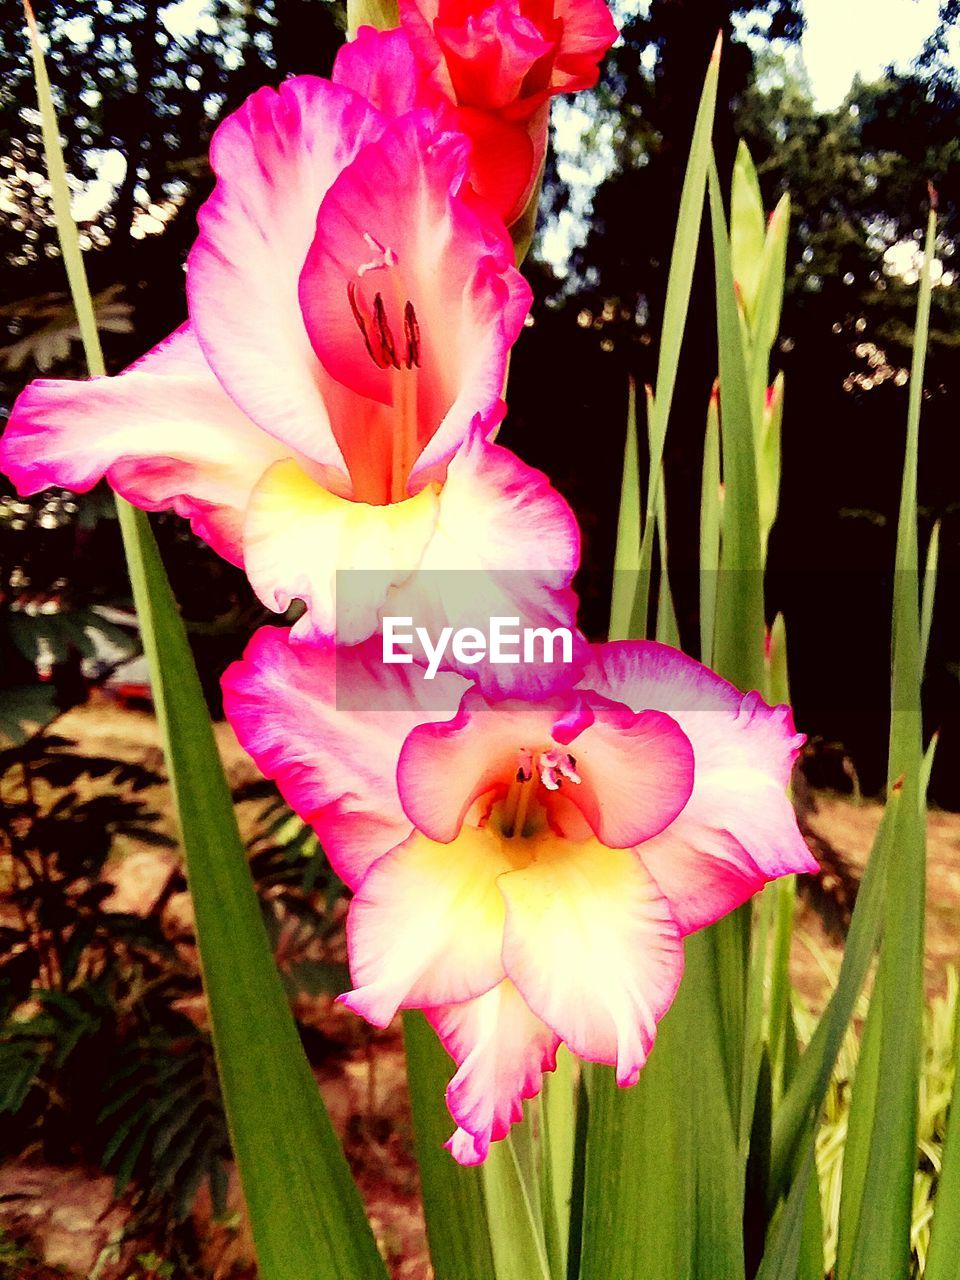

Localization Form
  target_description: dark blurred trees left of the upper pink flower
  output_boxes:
[0,0,344,721]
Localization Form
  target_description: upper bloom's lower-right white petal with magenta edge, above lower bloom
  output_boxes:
[390,429,586,698]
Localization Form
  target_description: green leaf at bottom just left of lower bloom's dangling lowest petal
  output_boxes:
[403,1012,497,1280]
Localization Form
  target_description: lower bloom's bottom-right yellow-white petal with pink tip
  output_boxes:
[499,835,684,1084]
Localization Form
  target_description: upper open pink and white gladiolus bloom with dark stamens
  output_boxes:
[0,77,579,643]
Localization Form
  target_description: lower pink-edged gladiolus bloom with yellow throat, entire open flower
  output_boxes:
[224,630,815,1164]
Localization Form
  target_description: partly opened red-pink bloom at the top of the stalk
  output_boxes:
[334,0,617,225]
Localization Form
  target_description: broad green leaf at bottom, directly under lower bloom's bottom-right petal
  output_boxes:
[580,931,744,1280]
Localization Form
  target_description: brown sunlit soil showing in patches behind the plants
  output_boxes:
[0,696,960,1280]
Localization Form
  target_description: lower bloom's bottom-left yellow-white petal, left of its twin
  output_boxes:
[340,827,511,1027]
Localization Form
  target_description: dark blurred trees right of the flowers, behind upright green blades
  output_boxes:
[506,0,960,805]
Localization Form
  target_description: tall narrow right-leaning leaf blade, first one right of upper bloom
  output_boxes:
[631,37,721,639]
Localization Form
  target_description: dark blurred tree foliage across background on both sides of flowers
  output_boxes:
[0,0,960,808]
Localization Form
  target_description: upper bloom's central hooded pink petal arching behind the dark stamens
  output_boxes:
[300,110,531,486]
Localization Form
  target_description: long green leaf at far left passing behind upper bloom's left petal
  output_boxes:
[24,5,385,1280]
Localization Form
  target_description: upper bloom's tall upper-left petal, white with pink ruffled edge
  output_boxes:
[187,76,383,467]
